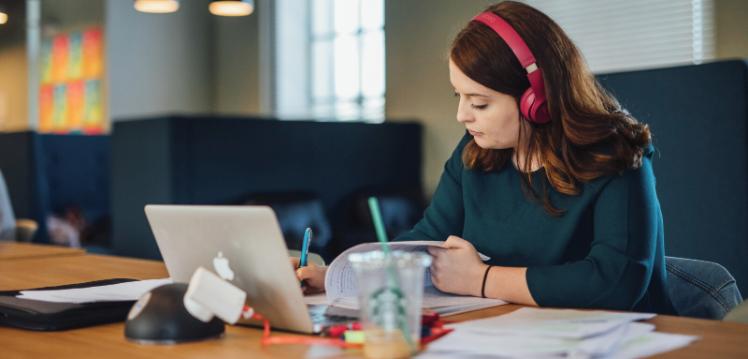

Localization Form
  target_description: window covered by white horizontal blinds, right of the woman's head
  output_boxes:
[525,0,714,73]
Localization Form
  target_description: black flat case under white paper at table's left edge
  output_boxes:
[0,278,135,331]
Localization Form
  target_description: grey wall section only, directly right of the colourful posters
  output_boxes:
[105,0,213,121]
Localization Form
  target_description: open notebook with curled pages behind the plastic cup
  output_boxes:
[308,241,506,316]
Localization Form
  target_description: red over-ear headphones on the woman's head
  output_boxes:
[473,11,551,124]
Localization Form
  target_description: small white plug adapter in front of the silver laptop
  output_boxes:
[183,267,247,324]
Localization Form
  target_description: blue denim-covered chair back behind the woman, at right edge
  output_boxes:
[665,257,743,319]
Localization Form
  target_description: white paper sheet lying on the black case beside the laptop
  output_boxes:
[17,278,172,303]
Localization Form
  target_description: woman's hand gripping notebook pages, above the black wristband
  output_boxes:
[427,236,487,297]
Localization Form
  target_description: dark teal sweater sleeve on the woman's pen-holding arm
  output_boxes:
[395,135,471,241]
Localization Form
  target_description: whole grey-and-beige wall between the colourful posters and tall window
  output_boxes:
[105,0,264,121]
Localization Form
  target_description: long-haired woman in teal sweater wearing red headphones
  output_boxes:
[298,1,673,313]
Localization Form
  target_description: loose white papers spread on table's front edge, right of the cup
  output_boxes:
[419,308,696,358]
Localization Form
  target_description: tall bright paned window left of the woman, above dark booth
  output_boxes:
[276,0,385,122]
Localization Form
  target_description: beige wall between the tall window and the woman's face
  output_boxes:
[385,0,491,197]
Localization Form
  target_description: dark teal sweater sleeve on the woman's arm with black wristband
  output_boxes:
[526,152,662,310]
